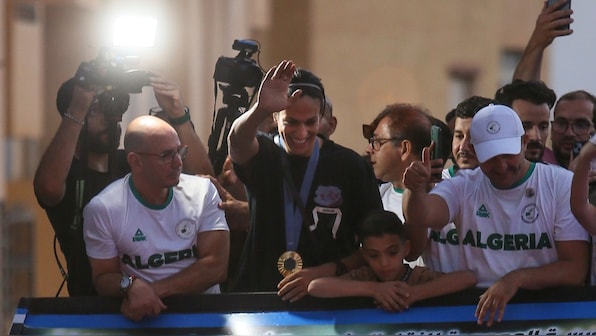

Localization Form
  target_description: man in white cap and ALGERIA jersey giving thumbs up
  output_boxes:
[403,105,589,326]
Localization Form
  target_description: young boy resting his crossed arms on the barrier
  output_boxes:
[308,210,476,311]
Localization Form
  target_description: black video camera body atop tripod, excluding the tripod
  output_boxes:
[213,40,263,88]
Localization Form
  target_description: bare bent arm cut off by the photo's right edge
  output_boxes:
[570,135,596,235]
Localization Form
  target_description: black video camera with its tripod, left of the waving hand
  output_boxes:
[207,40,263,174]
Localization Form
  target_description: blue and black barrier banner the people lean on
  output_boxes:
[11,287,596,335]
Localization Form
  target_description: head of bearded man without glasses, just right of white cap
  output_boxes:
[495,79,557,162]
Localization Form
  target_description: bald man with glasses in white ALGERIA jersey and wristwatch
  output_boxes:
[83,116,229,321]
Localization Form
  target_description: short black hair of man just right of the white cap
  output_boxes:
[495,79,557,109]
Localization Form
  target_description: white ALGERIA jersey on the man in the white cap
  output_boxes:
[430,163,588,287]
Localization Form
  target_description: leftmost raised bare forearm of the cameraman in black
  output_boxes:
[33,85,97,206]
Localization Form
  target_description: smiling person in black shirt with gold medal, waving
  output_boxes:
[228,61,382,302]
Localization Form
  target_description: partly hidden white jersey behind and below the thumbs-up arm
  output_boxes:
[422,166,462,273]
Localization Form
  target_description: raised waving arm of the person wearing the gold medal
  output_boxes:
[228,61,300,165]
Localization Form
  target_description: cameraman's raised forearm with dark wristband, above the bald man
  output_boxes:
[151,77,215,176]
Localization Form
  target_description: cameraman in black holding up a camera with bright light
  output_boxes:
[33,77,213,296]
